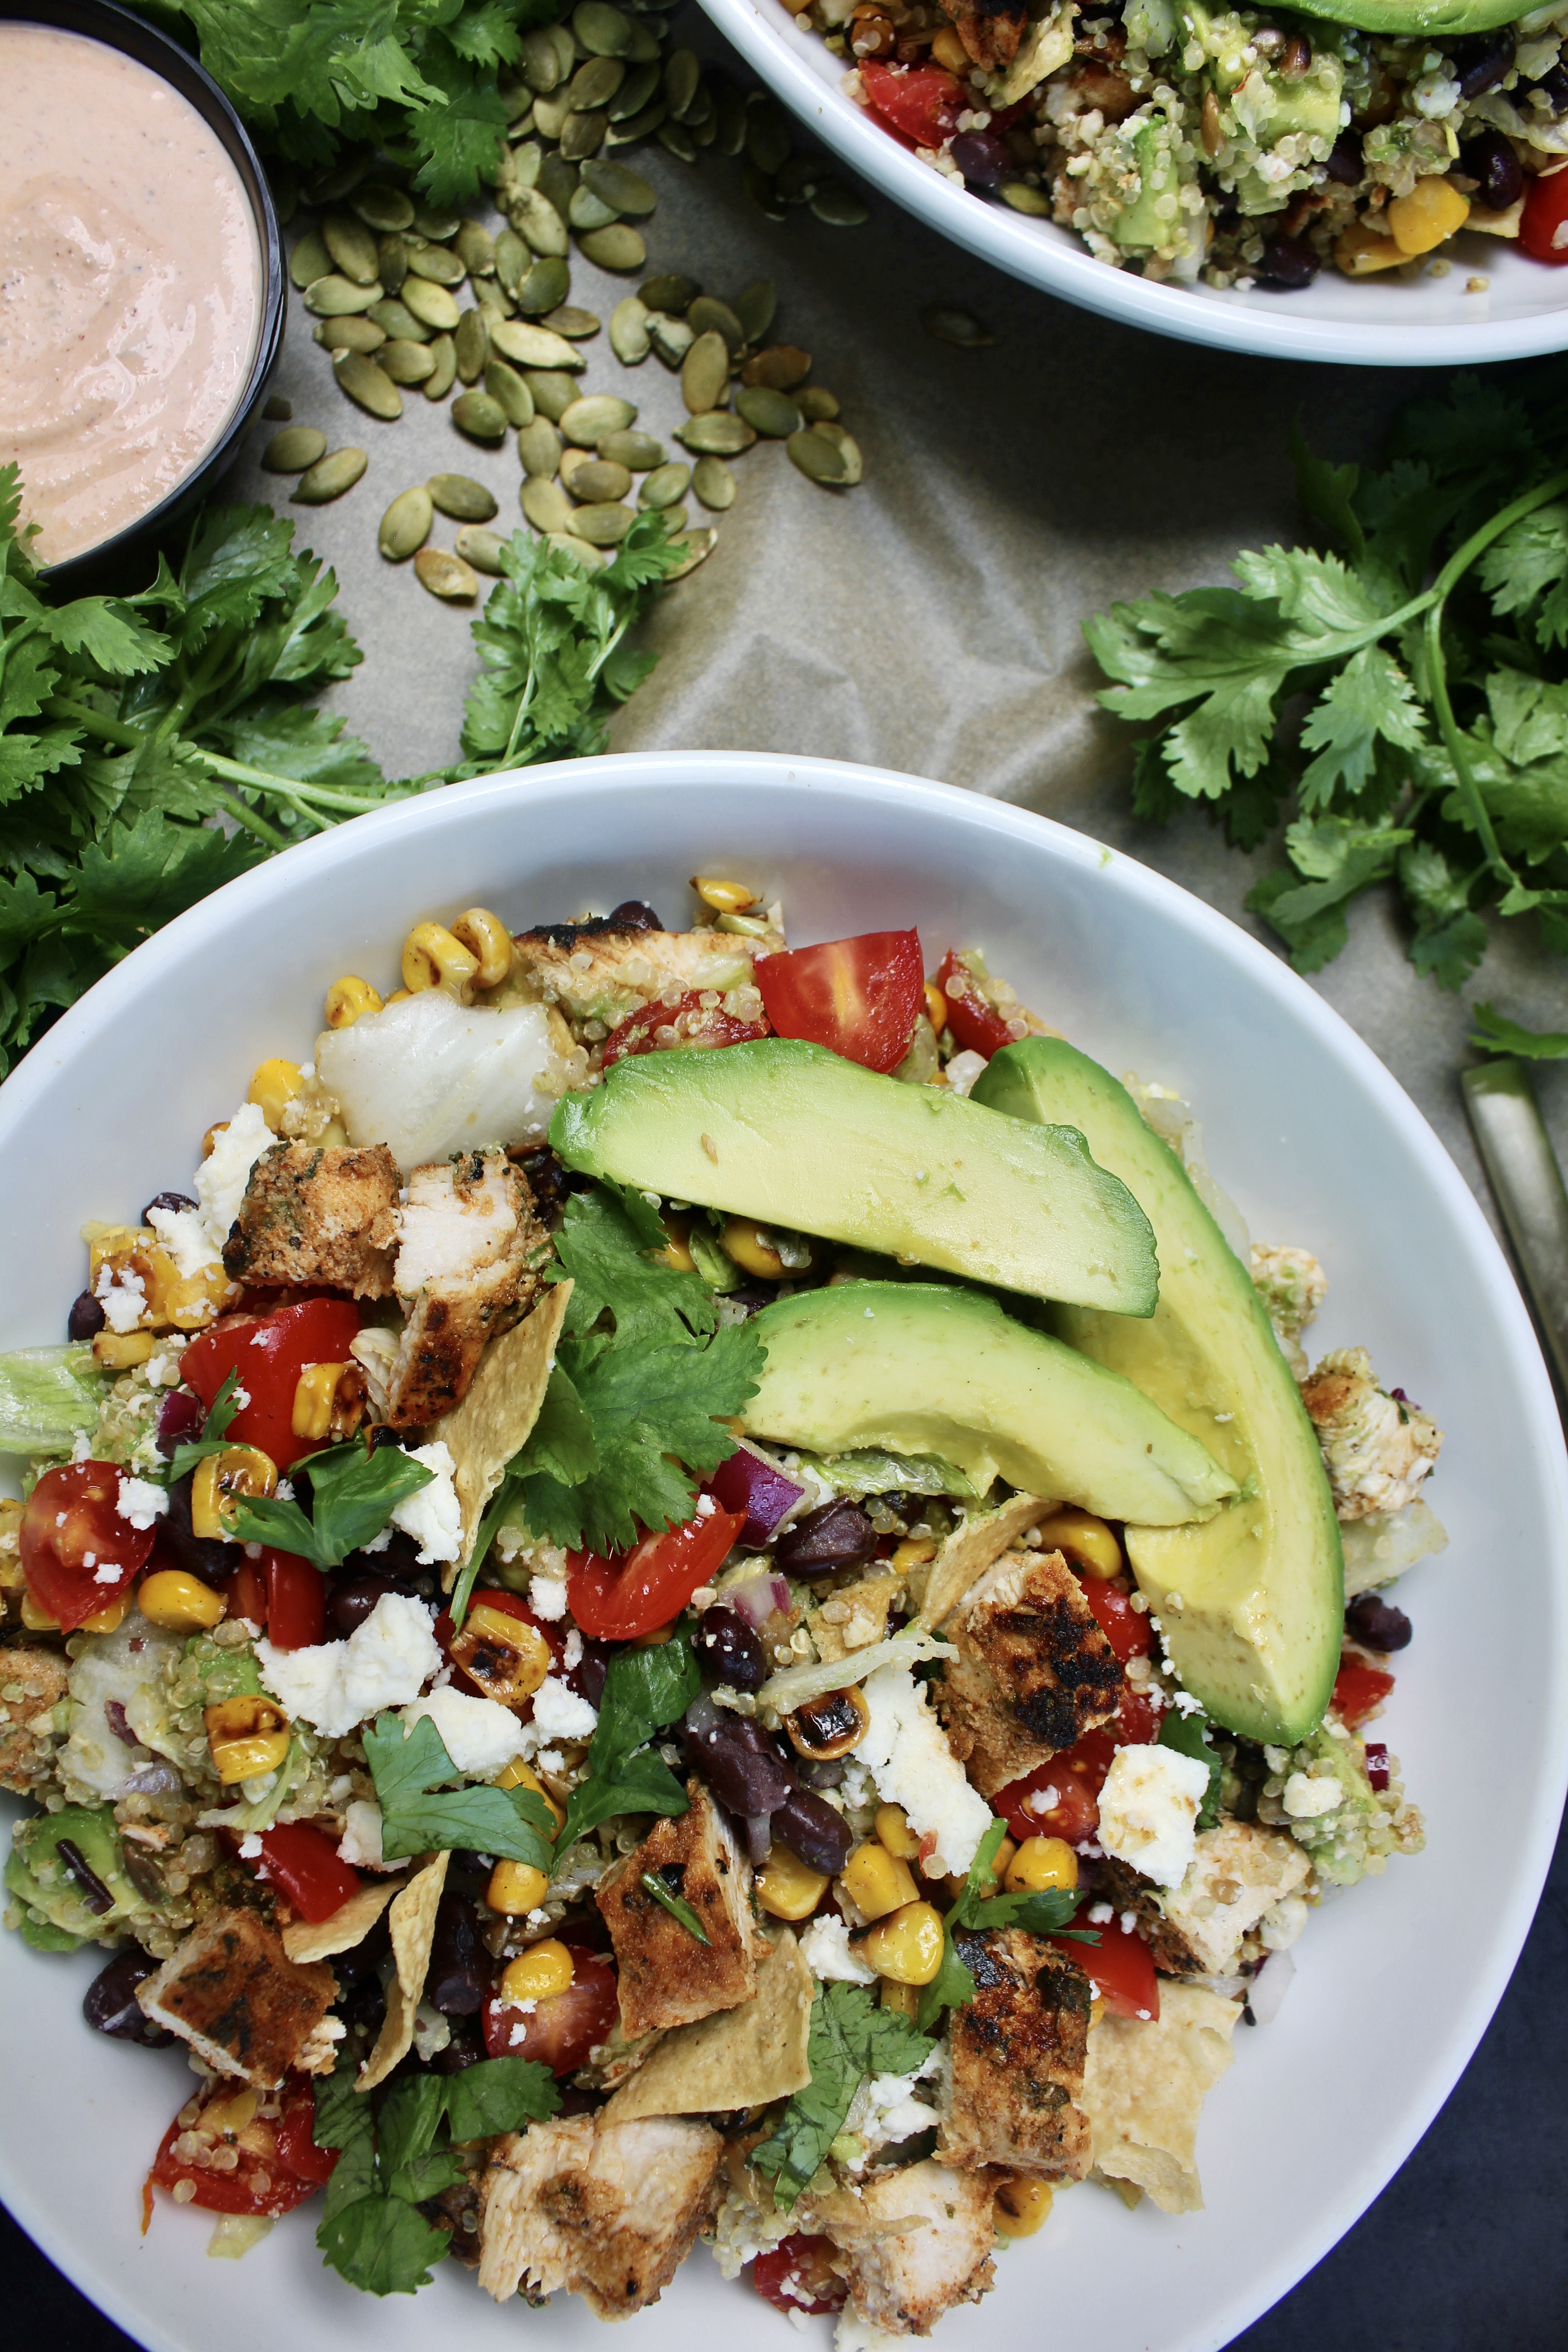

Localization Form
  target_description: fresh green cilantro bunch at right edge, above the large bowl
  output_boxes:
[1084,362,1568,997]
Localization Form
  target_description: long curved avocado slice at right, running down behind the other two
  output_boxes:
[975,1037,1345,1745]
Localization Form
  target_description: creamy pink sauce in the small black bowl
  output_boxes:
[0,21,263,562]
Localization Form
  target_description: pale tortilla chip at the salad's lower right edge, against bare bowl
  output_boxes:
[1079,1978,1241,2213]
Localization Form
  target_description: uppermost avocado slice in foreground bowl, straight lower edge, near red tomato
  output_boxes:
[550,1037,1159,1315]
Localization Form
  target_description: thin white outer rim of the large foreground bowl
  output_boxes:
[0,750,1568,2352]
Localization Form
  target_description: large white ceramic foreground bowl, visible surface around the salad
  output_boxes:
[0,753,1568,2352]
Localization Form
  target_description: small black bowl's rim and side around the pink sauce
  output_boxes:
[0,0,287,595]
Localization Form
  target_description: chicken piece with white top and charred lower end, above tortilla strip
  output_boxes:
[367,1150,550,1430]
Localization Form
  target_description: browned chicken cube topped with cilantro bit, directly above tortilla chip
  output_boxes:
[595,1780,764,2042]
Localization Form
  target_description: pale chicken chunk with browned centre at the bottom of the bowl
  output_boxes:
[480,2114,724,2319]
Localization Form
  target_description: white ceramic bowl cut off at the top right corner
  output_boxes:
[703,0,1568,367]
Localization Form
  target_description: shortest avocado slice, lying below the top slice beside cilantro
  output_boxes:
[738,1289,1236,1526]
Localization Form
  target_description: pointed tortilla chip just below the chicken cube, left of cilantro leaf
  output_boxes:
[604,1929,816,2124]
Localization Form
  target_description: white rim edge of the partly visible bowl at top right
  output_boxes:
[701,0,1568,367]
